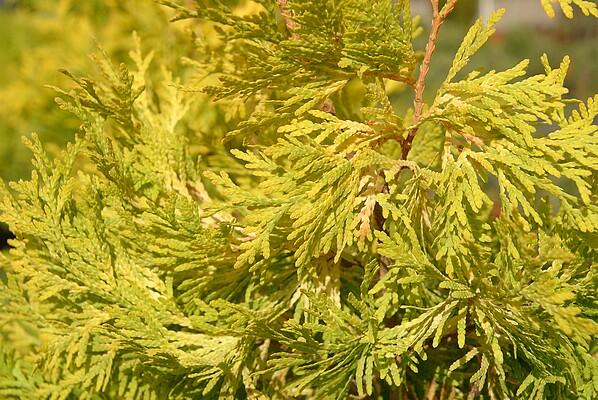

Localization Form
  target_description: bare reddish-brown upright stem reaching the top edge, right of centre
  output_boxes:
[401,0,458,160]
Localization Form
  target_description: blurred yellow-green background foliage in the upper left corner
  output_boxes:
[0,0,191,180]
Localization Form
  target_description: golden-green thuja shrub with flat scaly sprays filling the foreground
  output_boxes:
[0,0,598,400]
